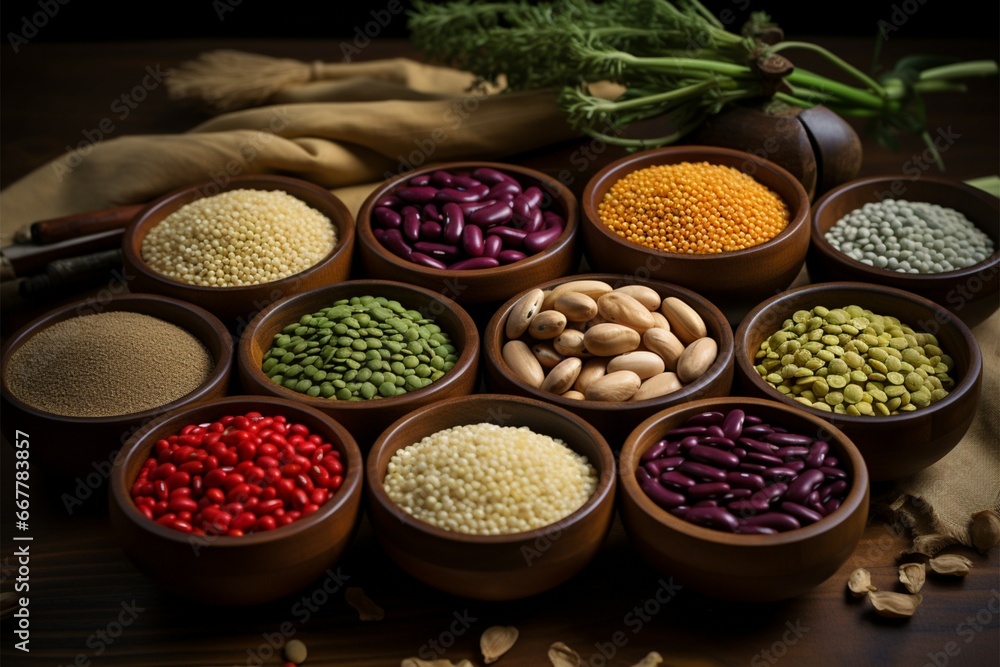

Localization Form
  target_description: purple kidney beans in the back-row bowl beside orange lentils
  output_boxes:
[371,167,566,270]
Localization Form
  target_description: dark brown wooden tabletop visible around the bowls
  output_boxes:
[0,35,1000,667]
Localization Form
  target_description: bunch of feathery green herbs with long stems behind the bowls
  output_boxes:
[409,0,998,166]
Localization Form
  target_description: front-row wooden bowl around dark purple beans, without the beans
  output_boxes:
[618,396,869,602]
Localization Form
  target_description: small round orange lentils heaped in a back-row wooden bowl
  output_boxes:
[597,162,789,254]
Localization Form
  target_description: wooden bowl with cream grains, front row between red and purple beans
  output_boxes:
[365,394,616,600]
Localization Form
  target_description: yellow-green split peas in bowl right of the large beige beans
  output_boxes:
[756,306,954,416]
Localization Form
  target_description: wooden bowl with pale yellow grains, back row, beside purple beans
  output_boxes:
[123,175,355,334]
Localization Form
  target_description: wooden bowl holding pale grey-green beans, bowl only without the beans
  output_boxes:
[806,176,1000,325]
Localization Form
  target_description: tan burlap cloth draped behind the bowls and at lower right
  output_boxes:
[0,51,1000,554]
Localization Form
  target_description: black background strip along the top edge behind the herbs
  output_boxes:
[0,0,1000,43]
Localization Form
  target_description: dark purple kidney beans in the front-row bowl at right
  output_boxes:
[636,408,850,535]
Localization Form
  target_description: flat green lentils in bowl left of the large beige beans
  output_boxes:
[261,296,458,401]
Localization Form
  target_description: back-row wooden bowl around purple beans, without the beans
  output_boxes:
[358,162,580,307]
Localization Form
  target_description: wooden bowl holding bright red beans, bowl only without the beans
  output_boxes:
[109,396,363,605]
